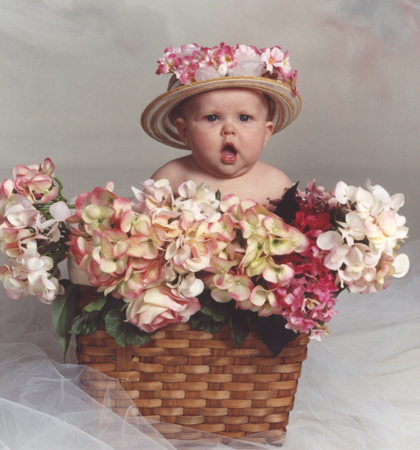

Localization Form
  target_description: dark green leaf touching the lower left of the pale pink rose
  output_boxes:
[105,308,154,347]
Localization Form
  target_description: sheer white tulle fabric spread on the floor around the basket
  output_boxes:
[0,241,420,450]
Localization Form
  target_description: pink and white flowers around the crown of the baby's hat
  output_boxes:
[156,42,298,95]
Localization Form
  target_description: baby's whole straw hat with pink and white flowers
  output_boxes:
[141,42,302,150]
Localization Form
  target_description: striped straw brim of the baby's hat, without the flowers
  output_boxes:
[141,76,302,150]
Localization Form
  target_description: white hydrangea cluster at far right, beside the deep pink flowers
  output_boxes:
[317,180,409,293]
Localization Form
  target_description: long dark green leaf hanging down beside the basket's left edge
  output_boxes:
[52,280,78,362]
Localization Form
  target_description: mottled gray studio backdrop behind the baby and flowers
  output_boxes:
[0,0,420,243]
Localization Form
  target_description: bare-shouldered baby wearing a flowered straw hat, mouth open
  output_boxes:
[142,44,300,205]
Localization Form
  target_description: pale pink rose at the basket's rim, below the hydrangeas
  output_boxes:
[127,285,200,333]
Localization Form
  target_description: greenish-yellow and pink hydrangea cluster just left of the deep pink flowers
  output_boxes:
[205,196,309,316]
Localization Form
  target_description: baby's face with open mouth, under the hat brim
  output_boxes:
[175,88,273,178]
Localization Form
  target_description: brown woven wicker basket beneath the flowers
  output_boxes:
[77,286,309,438]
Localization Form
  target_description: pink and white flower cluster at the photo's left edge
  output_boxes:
[0,158,71,303]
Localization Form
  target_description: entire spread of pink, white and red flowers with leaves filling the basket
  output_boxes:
[0,159,409,355]
